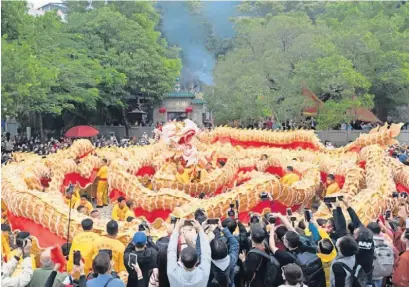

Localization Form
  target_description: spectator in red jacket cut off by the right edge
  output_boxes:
[392,228,409,287]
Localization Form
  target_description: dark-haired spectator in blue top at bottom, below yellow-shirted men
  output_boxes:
[87,252,125,287]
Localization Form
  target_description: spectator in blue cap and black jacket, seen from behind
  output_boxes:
[124,231,158,287]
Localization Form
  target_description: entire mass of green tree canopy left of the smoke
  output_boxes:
[1,1,181,137]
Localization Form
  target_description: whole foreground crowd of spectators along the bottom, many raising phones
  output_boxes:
[2,193,409,287]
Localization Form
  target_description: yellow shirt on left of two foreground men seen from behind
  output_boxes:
[67,231,100,274]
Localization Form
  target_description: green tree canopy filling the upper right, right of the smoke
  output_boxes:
[207,1,409,128]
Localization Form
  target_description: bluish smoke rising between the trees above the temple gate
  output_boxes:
[157,1,239,86]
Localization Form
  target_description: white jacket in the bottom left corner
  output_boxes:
[1,256,33,287]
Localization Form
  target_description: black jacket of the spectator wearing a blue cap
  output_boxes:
[124,242,158,287]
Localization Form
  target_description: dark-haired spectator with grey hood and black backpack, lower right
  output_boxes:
[330,236,358,287]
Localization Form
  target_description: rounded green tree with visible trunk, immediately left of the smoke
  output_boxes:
[66,5,181,136]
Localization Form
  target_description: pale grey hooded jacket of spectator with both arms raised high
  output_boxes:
[167,231,211,287]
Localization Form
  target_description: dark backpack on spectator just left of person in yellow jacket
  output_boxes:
[288,252,326,287]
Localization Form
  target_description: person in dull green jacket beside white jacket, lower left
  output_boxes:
[27,249,67,287]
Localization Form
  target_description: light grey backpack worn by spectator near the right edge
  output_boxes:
[373,244,395,278]
